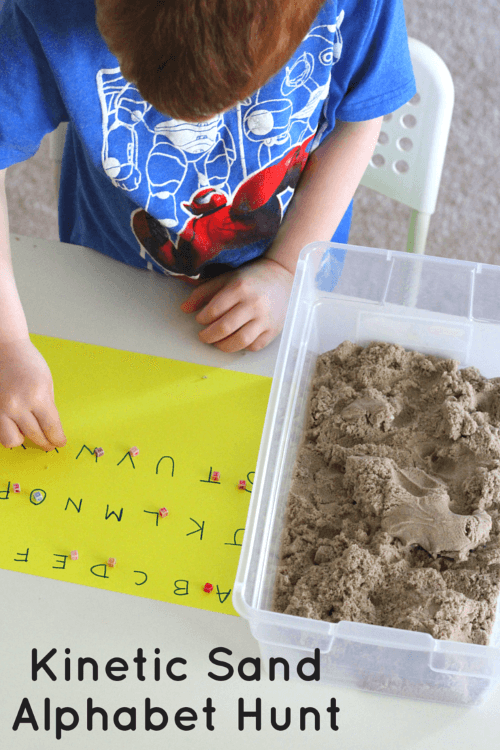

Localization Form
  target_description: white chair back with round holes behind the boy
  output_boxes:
[360,37,455,253]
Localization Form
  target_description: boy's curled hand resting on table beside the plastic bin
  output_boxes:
[181,257,293,352]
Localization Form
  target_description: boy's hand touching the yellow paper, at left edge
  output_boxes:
[0,339,66,451]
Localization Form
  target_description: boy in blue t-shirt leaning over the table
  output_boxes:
[0,0,415,450]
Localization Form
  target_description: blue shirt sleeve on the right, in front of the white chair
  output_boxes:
[331,0,416,122]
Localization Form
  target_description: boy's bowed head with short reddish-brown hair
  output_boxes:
[95,0,325,121]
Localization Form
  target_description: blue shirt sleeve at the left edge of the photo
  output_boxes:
[0,0,69,169]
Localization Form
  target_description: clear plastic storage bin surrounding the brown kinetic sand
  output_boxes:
[233,243,500,705]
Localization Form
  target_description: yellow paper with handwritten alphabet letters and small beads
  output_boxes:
[0,336,271,614]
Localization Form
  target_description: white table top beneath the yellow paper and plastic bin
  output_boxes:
[0,235,500,750]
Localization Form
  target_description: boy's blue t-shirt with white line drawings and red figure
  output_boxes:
[0,0,416,278]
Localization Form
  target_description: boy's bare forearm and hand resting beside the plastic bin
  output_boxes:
[181,117,383,352]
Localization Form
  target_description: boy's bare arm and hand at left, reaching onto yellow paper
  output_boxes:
[0,169,66,450]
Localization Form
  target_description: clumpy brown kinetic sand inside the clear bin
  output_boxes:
[274,341,500,645]
